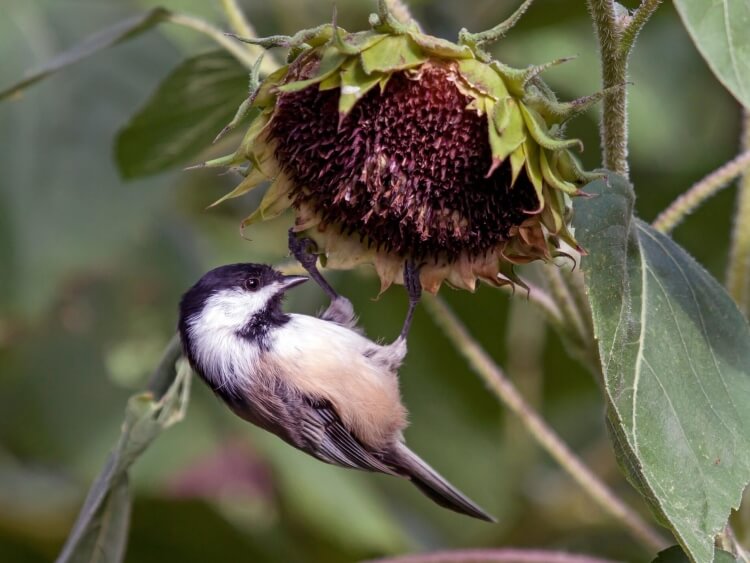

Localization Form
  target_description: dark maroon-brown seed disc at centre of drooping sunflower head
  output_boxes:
[269,63,539,260]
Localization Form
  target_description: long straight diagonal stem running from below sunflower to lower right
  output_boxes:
[423,297,668,550]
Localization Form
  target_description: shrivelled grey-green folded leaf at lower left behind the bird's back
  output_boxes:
[57,339,192,563]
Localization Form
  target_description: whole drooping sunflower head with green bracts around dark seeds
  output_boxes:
[207,3,598,292]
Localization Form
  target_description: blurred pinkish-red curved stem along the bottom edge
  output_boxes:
[365,548,616,563]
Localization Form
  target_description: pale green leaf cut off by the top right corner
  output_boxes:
[674,0,750,107]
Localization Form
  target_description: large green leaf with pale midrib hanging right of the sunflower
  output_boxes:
[575,175,750,561]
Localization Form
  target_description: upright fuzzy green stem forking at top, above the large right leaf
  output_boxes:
[588,0,661,178]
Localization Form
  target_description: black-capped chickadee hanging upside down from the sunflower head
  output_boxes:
[179,236,494,522]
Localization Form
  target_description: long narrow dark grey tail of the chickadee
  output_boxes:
[397,444,497,522]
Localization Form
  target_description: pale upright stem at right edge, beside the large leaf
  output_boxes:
[727,109,750,316]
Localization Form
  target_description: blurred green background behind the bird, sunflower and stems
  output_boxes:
[0,0,739,563]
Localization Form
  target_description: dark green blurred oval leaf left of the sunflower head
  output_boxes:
[115,51,253,179]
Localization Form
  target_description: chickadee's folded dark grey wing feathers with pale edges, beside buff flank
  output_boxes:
[301,401,399,475]
